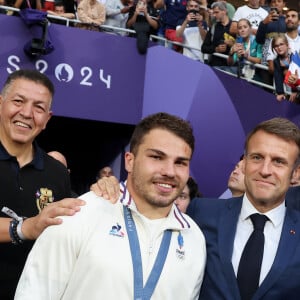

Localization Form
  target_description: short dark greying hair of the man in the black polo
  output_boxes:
[1,69,55,97]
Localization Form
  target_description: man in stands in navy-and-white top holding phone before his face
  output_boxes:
[176,0,207,62]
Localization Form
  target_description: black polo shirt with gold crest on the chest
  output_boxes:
[0,143,71,300]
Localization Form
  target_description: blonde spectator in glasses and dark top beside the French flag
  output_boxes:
[271,33,291,101]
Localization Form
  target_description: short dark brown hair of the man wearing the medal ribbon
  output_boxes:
[130,112,195,154]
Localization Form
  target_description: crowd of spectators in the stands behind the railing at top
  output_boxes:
[0,0,300,103]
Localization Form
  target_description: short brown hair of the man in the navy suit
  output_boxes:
[245,117,300,165]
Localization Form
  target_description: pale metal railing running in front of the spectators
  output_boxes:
[0,5,274,92]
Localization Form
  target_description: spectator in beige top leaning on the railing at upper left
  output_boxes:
[77,0,106,31]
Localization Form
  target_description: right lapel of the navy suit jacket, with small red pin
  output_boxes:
[254,208,300,299]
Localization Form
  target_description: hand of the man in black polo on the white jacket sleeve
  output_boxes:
[22,198,85,240]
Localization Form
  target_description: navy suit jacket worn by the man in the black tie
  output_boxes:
[187,197,300,300]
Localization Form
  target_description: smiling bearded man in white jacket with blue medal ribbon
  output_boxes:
[15,113,206,300]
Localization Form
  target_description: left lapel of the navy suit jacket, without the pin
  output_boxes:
[218,197,243,299]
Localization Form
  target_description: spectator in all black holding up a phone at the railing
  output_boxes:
[126,0,159,54]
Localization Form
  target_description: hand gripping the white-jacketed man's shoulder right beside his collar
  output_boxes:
[90,176,120,203]
